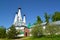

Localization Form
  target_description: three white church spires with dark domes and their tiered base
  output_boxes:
[13,8,26,26]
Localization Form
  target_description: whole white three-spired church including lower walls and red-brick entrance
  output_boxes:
[13,8,30,37]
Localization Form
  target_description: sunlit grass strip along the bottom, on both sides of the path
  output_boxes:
[0,35,60,40]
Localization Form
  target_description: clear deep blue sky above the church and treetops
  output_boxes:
[0,0,60,28]
